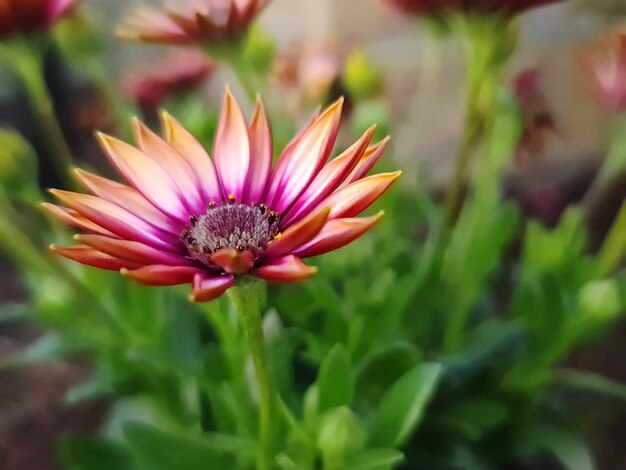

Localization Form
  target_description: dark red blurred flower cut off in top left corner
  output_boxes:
[0,0,73,38]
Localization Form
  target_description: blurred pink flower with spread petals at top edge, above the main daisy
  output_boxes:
[118,0,270,44]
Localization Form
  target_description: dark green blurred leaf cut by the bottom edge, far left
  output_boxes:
[59,436,134,470]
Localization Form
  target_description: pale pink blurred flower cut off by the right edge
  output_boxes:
[578,30,626,111]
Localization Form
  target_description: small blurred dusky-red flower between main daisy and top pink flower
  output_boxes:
[122,50,215,115]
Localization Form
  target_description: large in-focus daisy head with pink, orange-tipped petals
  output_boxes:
[44,91,401,301]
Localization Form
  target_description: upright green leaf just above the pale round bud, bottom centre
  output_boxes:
[317,344,354,412]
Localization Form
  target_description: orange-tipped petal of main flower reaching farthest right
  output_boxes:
[320,171,402,219]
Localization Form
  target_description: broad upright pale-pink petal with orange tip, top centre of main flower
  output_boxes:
[213,89,250,200]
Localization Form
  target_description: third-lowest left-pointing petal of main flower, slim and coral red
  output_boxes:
[74,235,192,266]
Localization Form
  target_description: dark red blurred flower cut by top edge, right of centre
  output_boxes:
[384,0,563,16]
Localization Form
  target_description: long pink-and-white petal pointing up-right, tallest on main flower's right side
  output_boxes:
[266,98,343,212]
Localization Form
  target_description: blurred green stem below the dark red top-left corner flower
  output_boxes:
[10,45,74,187]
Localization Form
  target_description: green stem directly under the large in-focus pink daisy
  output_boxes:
[228,279,277,470]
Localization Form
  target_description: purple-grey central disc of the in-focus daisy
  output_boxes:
[181,197,280,264]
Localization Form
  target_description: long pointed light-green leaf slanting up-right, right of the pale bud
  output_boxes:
[369,363,442,447]
